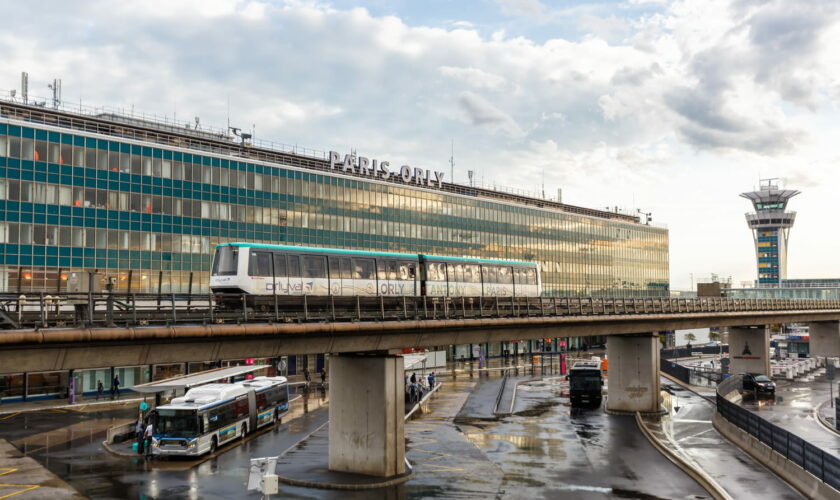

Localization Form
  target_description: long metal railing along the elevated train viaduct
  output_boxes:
[0,292,840,329]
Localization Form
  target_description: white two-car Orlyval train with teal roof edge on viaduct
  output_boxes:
[210,243,541,297]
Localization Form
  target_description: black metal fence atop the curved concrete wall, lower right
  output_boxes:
[717,377,840,490]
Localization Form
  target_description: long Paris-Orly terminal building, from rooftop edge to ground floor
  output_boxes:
[0,99,669,400]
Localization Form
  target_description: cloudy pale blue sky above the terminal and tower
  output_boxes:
[0,0,840,289]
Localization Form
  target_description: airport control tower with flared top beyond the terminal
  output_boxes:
[741,179,800,287]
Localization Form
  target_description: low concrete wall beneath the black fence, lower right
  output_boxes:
[712,412,840,500]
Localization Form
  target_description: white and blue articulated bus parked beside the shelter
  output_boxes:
[152,377,289,456]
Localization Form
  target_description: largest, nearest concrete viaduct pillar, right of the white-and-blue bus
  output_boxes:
[329,355,405,477]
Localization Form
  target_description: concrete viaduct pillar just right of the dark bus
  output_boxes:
[607,333,659,412]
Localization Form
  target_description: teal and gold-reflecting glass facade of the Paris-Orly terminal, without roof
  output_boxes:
[0,111,669,297]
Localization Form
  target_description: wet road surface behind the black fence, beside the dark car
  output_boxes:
[741,375,840,457]
